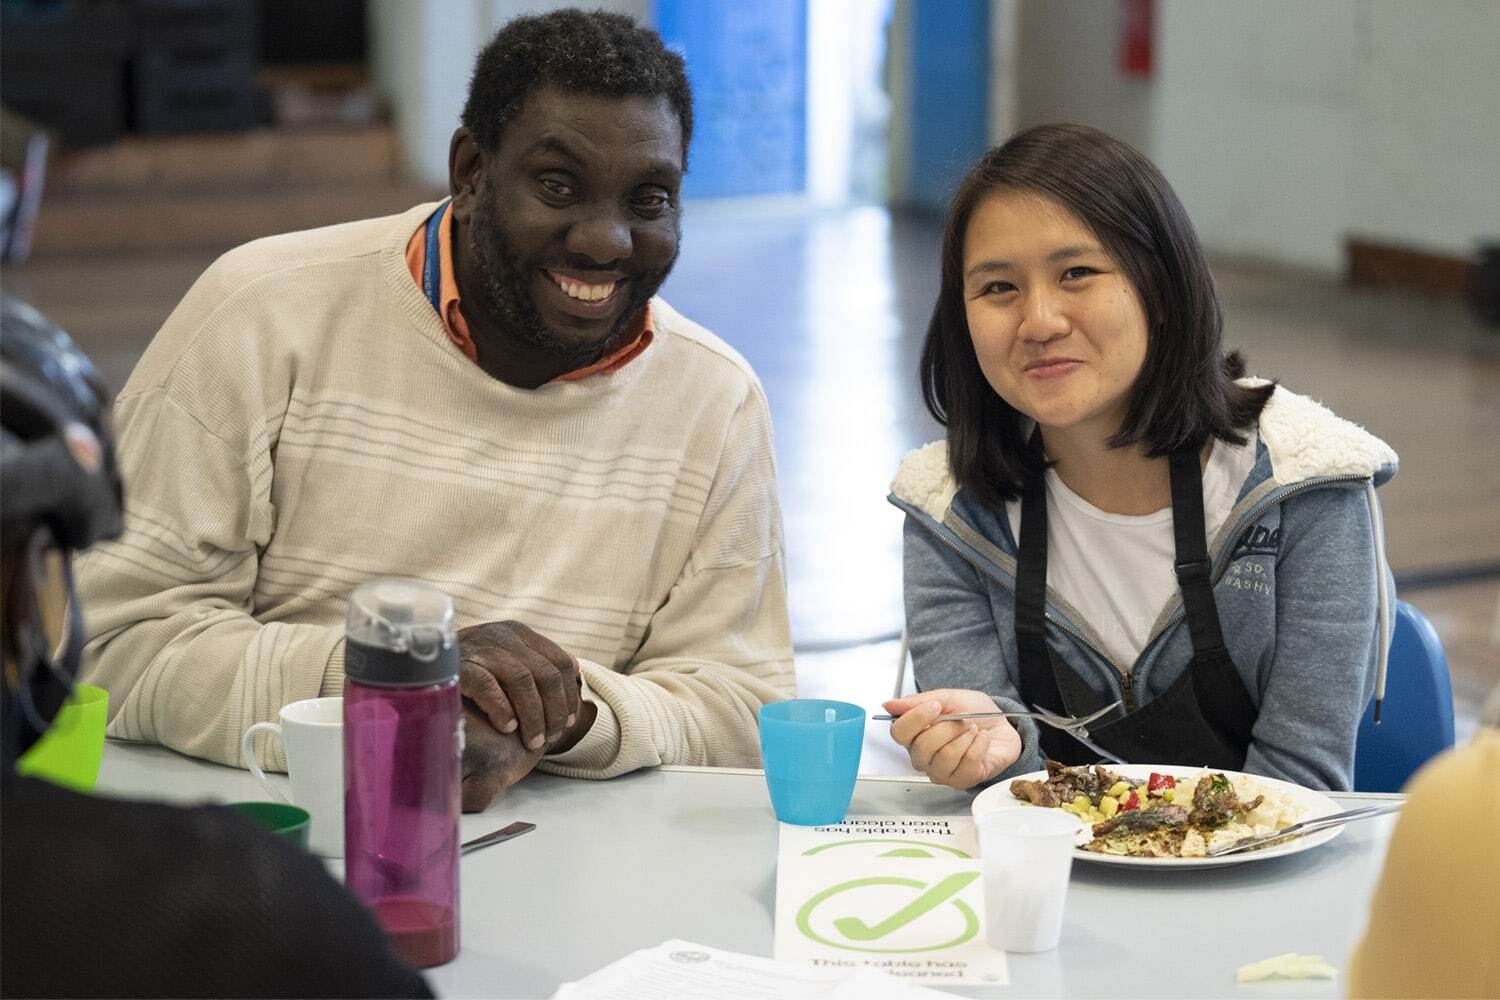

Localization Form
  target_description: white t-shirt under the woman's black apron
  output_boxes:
[1007,432,1256,670]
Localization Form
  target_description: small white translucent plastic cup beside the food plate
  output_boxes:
[980,808,1079,952]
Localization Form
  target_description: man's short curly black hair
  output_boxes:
[464,7,693,166]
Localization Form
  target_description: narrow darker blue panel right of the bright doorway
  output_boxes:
[908,0,990,208]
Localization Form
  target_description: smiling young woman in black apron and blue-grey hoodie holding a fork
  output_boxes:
[887,124,1397,789]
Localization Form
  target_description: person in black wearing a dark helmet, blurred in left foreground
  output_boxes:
[0,298,432,997]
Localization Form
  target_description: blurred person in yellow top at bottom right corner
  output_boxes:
[1349,688,1500,999]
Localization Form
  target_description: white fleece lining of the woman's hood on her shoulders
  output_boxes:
[891,378,1397,522]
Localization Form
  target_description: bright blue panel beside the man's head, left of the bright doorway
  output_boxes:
[656,0,807,198]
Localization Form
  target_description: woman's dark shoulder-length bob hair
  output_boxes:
[921,124,1274,510]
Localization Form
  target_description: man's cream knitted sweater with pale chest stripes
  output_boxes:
[80,205,794,778]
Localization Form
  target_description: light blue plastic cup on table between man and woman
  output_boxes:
[761,699,864,826]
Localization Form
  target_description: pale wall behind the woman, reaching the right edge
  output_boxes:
[1019,0,1500,271]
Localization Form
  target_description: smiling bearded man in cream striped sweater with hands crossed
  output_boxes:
[81,10,794,810]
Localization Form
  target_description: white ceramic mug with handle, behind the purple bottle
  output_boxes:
[240,697,344,858]
